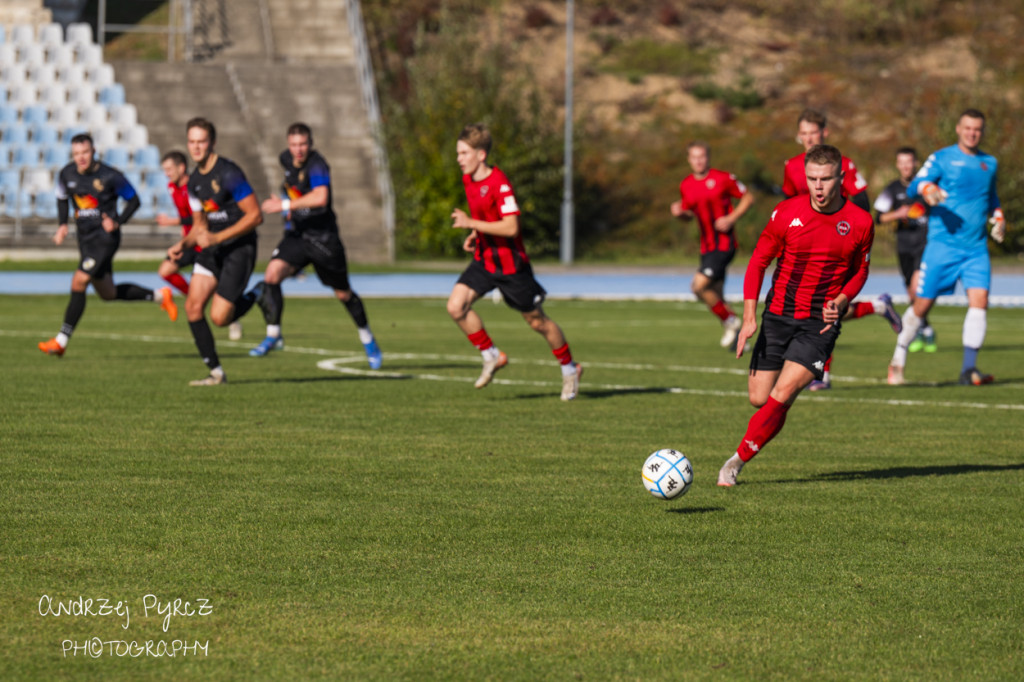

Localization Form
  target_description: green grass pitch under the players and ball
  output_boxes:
[0,295,1024,680]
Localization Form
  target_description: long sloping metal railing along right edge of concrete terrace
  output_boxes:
[345,0,395,261]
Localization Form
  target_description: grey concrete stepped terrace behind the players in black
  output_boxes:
[114,0,388,262]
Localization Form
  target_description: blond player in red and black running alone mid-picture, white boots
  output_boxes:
[447,124,583,400]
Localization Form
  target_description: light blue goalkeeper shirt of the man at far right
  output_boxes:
[907,144,999,251]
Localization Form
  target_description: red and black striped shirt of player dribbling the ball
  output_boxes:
[743,195,874,319]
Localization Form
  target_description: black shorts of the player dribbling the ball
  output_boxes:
[751,310,840,381]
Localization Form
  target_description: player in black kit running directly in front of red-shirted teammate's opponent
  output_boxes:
[167,118,263,386]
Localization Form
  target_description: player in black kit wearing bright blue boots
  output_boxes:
[249,123,382,370]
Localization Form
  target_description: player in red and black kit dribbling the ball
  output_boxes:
[718,144,874,487]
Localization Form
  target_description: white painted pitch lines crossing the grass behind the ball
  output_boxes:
[0,330,1024,412]
